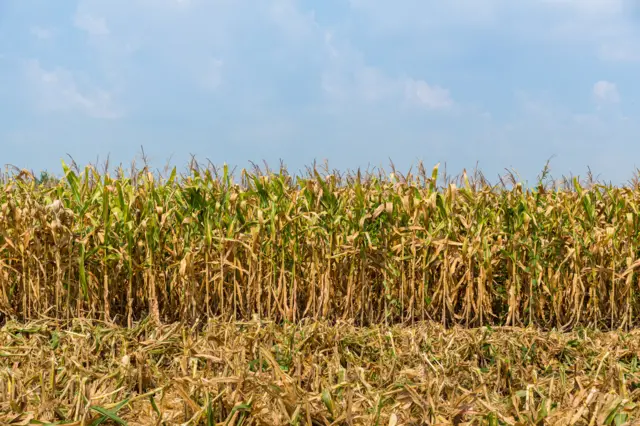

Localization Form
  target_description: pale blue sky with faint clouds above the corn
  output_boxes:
[0,0,640,183]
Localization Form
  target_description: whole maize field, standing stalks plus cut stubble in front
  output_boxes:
[0,162,640,426]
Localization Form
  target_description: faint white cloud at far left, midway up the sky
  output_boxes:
[26,60,121,119]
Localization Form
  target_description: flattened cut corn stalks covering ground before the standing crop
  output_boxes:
[0,320,640,426]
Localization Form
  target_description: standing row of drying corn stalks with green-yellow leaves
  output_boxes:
[0,163,640,330]
